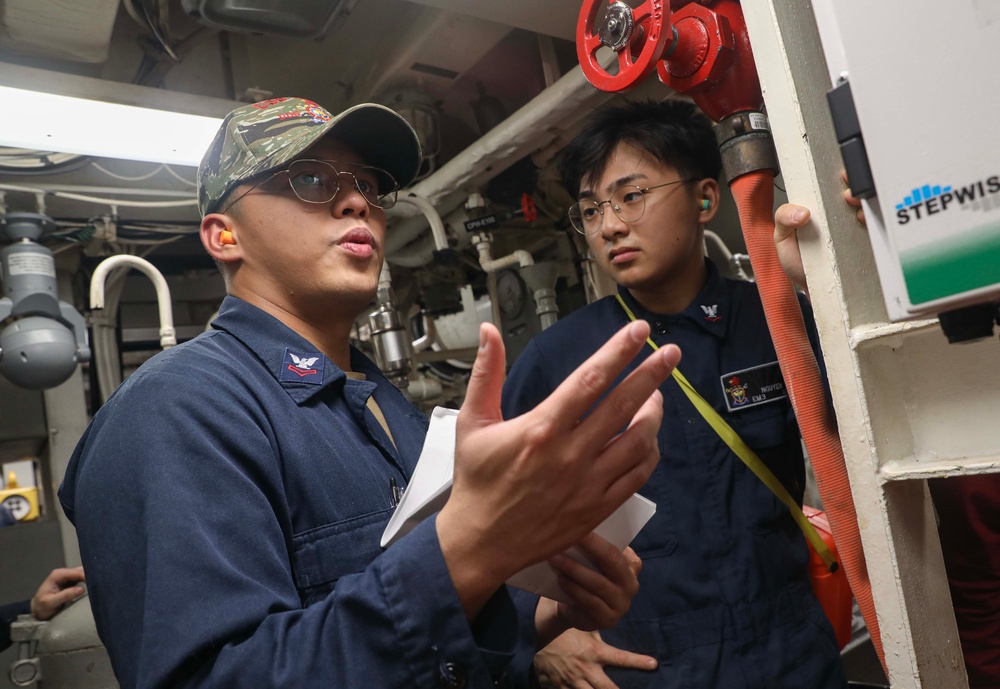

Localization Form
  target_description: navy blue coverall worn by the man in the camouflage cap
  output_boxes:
[59,297,519,689]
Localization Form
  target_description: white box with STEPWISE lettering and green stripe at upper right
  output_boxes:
[814,0,1000,321]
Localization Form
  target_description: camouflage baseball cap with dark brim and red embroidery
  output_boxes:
[198,98,420,215]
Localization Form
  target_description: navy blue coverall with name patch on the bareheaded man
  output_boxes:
[503,262,846,689]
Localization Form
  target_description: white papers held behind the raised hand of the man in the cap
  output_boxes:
[381,407,656,602]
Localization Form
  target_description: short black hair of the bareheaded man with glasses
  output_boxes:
[559,100,722,198]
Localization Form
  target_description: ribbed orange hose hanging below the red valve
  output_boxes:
[730,170,885,668]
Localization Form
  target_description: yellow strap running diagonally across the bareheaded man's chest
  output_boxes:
[615,294,838,572]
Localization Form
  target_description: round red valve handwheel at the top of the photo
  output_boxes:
[576,0,672,92]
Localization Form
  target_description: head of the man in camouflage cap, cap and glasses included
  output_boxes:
[198,98,420,328]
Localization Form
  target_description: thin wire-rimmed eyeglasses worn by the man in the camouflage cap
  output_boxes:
[219,158,399,213]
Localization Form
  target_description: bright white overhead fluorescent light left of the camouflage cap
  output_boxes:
[0,86,222,166]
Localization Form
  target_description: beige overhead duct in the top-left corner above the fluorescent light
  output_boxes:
[0,0,119,62]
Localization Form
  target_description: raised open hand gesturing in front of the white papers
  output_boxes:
[437,321,680,617]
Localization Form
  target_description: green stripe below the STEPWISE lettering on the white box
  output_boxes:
[900,222,1000,304]
